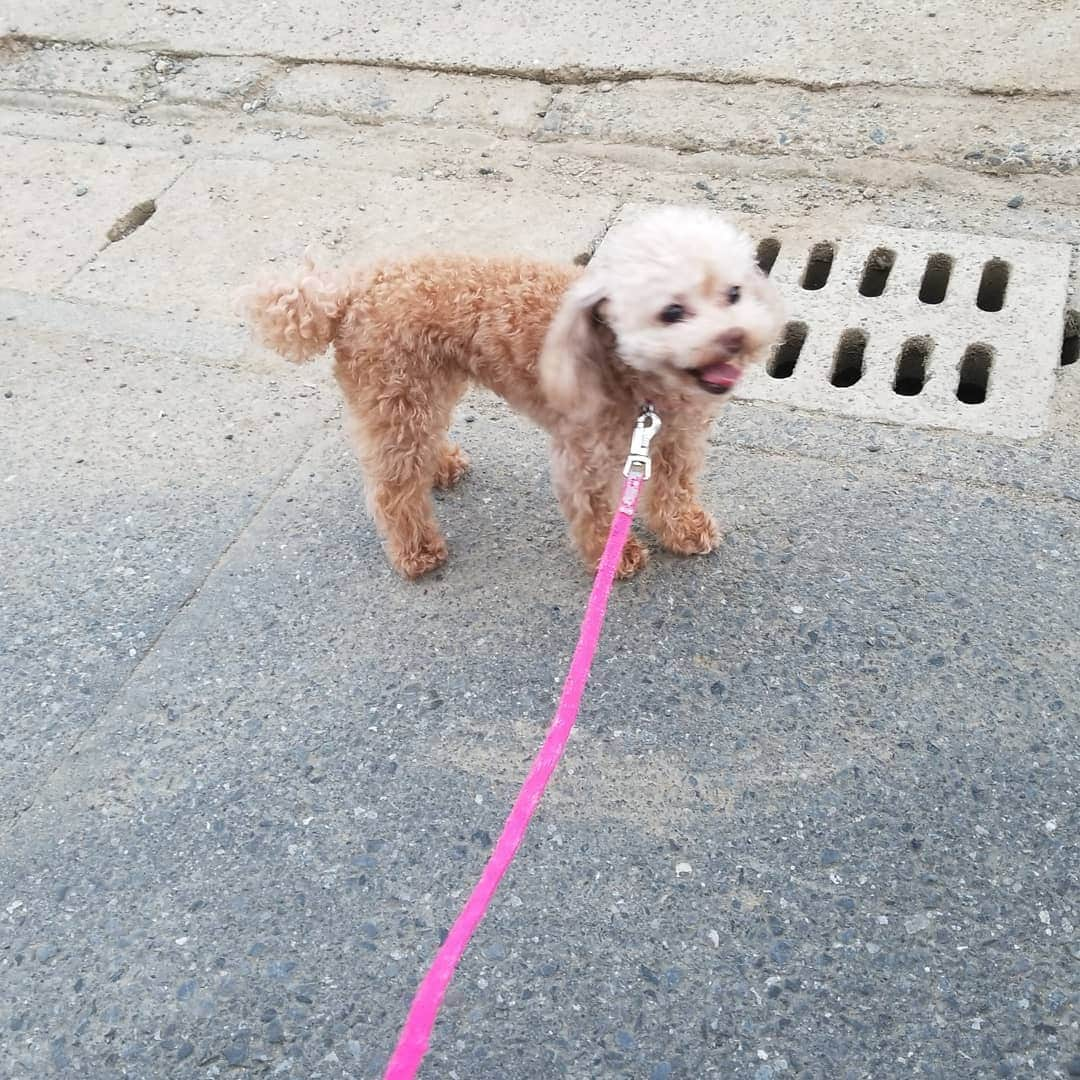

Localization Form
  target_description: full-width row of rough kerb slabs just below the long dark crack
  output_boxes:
[8,42,1080,176]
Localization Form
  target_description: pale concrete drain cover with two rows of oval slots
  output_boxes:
[740,228,1069,438]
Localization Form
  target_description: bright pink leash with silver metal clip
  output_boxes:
[384,405,660,1080]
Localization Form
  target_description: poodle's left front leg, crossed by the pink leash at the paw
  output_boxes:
[552,440,649,578]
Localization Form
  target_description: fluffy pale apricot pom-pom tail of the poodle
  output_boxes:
[238,254,351,364]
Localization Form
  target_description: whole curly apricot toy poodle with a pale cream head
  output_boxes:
[243,206,783,578]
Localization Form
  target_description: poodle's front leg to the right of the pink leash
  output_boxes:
[645,422,721,555]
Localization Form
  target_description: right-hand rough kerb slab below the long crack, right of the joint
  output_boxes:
[543,78,1080,175]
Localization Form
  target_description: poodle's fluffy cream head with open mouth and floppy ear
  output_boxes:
[540,206,783,407]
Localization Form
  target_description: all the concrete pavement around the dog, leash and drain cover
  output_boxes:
[0,8,1080,1080]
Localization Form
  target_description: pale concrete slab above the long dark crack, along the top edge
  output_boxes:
[6,0,1080,92]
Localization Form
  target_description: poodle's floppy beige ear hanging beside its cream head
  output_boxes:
[539,274,611,414]
